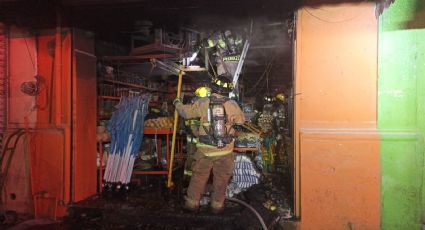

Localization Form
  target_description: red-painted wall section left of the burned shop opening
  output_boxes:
[5,28,96,218]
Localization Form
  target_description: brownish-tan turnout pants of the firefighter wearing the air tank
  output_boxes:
[186,152,234,210]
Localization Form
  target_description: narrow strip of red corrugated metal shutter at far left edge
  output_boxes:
[0,22,8,152]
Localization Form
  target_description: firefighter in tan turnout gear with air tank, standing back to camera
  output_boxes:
[174,78,245,213]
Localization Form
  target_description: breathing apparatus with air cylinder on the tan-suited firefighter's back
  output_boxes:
[199,96,232,148]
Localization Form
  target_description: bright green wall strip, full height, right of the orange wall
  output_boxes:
[378,0,425,229]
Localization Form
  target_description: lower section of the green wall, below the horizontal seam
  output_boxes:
[381,139,422,229]
